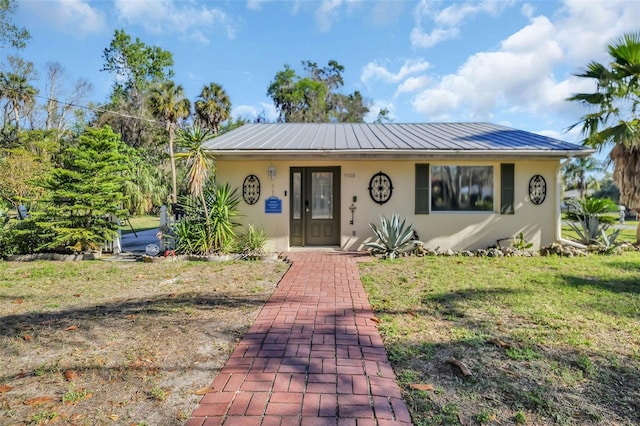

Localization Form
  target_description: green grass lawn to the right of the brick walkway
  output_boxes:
[360,252,640,425]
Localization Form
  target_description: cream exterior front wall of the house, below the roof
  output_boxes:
[216,157,559,251]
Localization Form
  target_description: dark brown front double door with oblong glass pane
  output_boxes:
[289,167,340,246]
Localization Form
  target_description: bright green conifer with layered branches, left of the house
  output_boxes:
[32,127,134,252]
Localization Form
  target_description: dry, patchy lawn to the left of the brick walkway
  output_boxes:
[0,261,288,425]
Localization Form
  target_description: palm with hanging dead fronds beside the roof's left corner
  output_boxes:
[176,125,215,241]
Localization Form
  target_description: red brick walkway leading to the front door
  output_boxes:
[186,252,411,426]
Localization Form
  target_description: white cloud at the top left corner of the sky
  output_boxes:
[20,0,106,36]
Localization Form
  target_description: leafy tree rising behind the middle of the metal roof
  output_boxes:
[267,60,369,123]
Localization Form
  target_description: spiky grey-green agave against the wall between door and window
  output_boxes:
[365,213,416,260]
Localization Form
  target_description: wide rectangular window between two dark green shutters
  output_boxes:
[430,166,493,212]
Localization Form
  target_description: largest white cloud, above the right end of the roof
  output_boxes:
[413,0,640,127]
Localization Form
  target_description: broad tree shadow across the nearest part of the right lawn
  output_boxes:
[386,326,640,425]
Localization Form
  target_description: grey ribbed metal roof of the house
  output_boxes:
[204,123,593,158]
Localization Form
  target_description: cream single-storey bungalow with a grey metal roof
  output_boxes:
[205,123,593,251]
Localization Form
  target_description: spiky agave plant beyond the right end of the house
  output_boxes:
[567,197,620,246]
